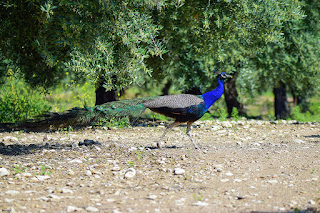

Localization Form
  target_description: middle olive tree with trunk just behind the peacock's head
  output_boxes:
[149,0,301,114]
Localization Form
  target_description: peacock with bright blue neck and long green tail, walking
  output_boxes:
[11,72,232,149]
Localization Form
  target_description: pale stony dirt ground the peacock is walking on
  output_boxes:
[0,120,320,213]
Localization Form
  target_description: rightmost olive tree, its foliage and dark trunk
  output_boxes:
[241,0,320,119]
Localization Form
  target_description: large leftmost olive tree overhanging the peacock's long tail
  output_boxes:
[0,0,165,104]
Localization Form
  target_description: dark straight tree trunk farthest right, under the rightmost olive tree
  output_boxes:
[273,82,290,119]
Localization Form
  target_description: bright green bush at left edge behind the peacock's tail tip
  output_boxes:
[0,68,51,123]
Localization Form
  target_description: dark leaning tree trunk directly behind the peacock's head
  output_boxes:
[224,72,246,116]
